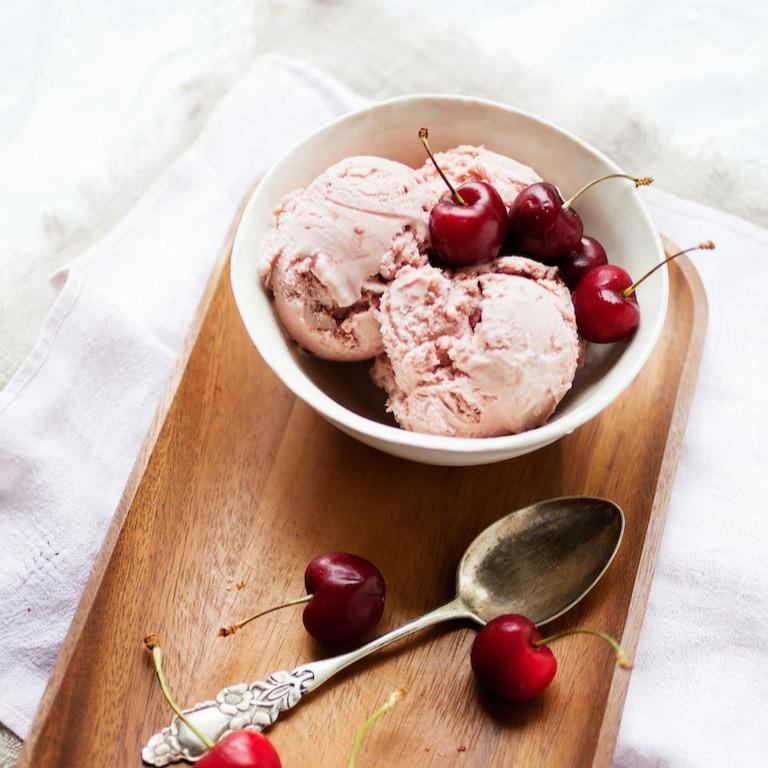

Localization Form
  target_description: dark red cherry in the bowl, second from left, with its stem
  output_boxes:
[506,173,653,264]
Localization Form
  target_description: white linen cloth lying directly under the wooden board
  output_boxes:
[0,57,768,766]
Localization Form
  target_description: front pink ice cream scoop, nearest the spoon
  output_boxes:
[371,256,580,437]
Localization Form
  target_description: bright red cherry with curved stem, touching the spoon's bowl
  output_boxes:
[471,613,630,703]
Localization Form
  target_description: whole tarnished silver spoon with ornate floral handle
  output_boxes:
[141,496,624,766]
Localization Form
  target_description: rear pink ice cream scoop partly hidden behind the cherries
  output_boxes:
[416,144,541,208]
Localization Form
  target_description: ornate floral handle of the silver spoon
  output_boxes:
[141,597,478,766]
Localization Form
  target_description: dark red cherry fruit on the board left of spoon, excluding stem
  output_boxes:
[303,552,385,643]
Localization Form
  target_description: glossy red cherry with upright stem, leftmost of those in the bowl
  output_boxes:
[419,128,507,267]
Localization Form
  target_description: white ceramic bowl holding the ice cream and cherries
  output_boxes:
[231,95,668,465]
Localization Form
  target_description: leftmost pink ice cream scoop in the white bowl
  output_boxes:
[259,157,428,360]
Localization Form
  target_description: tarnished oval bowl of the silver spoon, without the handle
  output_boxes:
[456,496,624,624]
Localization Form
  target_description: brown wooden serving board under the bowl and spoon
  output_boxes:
[20,202,707,768]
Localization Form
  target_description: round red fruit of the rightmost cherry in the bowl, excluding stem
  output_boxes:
[571,264,640,344]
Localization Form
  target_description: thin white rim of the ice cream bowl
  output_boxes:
[229,92,669,455]
